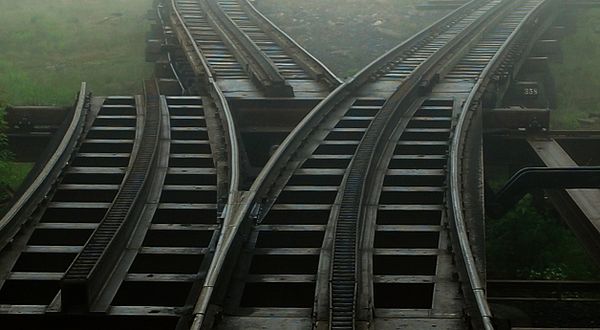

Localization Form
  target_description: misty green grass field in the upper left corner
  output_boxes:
[0,0,152,105]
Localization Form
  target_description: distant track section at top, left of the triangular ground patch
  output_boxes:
[167,0,340,97]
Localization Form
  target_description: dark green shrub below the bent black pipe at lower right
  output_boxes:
[486,195,600,280]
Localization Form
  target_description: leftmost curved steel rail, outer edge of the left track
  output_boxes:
[0,82,90,250]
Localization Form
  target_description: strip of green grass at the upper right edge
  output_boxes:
[551,9,600,129]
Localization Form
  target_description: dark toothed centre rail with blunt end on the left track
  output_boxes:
[61,80,161,311]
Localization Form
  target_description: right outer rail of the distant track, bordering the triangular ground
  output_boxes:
[239,0,344,87]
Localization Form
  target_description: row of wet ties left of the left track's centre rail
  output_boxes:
[0,97,143,309]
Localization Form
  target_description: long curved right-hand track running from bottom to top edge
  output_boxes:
[186,0,545,329]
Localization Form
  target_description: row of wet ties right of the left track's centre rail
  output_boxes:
[104,97,219,324]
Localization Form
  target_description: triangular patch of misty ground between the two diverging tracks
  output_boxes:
[253,0,447,78]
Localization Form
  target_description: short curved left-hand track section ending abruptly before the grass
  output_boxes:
[0,74,237,329]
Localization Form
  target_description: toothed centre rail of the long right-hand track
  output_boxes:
[330,1,510,329]
